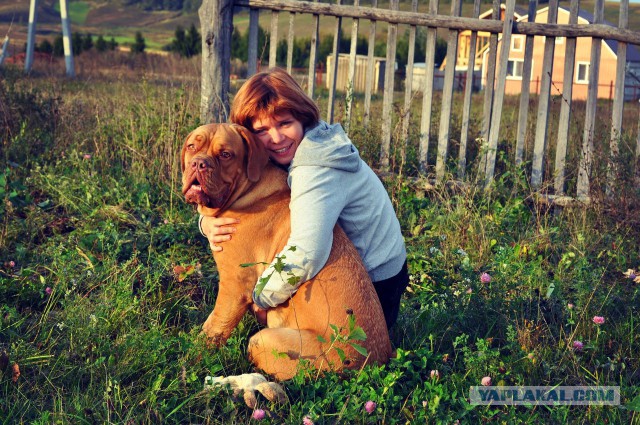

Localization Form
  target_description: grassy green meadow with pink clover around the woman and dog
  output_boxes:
[0,55,640,424]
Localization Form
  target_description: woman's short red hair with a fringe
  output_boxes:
[229,68,320,131]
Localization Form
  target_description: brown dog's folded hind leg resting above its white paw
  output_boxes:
[248,328,352,381]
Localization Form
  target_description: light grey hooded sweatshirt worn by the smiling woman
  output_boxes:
[253,121,407,308]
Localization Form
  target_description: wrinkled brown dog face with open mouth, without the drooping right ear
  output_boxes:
[182,124,244,208]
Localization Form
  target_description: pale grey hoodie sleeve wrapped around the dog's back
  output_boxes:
[253,166,348,308]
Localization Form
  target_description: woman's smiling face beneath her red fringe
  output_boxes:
[252,112,304,165]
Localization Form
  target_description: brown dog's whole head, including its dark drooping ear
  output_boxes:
[182,124,269,214]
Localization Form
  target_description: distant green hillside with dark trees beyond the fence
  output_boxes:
[0,0,640,55]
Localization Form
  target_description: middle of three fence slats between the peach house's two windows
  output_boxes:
[531,0,558,189]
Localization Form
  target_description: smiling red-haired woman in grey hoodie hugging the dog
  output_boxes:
[200,68,409,328]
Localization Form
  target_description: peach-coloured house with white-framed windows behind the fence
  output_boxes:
[482,7,640,100]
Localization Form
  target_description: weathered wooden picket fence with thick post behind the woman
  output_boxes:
[199,0,640,205]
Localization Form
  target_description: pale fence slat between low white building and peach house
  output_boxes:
[436,0,462,182]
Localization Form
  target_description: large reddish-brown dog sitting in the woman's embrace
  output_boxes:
[182,124,391,380]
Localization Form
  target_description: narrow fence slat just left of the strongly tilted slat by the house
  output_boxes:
[478,0,500,176]
